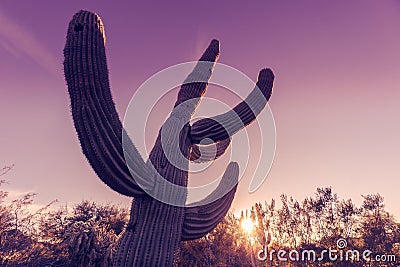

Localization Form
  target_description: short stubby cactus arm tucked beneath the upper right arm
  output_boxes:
[189,138,231,163]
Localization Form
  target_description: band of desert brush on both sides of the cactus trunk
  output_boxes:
[0,168,400,266]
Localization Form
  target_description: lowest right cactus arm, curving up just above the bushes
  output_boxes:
[182,162,239,241]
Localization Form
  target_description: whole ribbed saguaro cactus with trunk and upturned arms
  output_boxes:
[64,11,274,266]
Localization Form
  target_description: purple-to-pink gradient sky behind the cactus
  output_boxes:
[0,0,400,219]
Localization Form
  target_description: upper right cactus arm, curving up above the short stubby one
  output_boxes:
[190,69,274,144]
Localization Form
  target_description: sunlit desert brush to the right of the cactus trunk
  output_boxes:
[177,187,400,266]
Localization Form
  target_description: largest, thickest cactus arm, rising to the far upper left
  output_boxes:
[64,10,152,197]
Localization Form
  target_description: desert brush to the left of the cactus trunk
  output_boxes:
[0,169,128,266]
